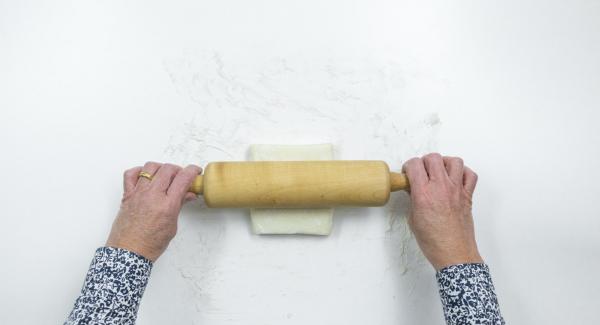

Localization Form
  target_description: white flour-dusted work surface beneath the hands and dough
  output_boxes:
[0,0,600,324]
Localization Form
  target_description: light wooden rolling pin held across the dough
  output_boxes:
[190,160,409,208]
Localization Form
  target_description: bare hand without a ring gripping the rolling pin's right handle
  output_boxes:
[402,153,483,270]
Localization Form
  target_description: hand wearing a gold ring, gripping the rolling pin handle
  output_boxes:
[106,162,202,261]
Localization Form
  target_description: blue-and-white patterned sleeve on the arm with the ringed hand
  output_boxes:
[65,247,152,325]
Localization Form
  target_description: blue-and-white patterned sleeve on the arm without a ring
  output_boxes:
[436,264,505,325]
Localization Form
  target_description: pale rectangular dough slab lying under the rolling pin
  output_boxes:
[250,144,333,235]
